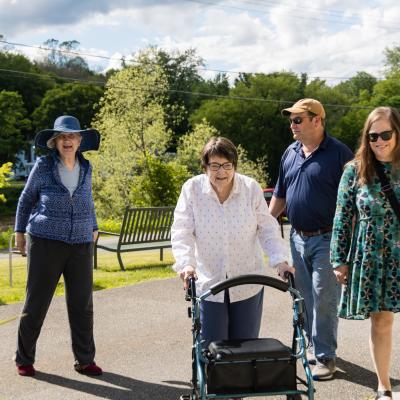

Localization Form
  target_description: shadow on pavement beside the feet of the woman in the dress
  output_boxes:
[335,357,400,390]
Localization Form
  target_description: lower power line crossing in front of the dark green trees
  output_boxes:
[0,68,372,110]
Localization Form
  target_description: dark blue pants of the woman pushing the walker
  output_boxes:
[200,289,264,348]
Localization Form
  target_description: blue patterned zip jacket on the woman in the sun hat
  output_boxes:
[15,152,98,244]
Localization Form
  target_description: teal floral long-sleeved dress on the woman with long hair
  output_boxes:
[331,162,400,319]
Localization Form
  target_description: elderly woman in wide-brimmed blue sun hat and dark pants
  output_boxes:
[15,115,102,376]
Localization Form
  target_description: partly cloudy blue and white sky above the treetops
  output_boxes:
[0,0,400,85]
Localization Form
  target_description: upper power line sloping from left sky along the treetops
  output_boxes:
[0,38,388,80]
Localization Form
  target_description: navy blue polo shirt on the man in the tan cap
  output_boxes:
[274,133,353,232]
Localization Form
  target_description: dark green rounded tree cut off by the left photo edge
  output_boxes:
[0,90,30,164]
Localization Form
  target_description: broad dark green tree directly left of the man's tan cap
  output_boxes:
[190,72,303,183]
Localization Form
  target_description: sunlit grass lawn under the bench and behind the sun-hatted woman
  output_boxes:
[0,249,176,305]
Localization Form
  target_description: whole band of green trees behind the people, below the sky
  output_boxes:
[0,39,400,215]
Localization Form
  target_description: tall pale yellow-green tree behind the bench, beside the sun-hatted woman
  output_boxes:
[91,52,171,216]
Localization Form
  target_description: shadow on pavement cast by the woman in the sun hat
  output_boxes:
[33,371,187,400]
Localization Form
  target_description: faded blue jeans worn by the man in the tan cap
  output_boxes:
[290,229,341,360]
